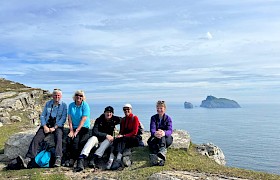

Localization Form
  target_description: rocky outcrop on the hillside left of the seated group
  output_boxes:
[0,78,51,126]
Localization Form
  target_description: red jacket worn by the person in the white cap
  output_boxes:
[120,113,139,137]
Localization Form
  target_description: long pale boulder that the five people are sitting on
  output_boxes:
[4,127,191,160]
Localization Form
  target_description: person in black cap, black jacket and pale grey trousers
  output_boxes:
[76,106,121,171]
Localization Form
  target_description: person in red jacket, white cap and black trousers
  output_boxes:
[106,104,140,170]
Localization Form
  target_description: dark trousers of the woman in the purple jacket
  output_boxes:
[147,136,173,154]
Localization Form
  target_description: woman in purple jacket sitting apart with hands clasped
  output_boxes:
[148,101,173,166]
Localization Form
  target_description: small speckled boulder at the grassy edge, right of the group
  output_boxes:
[196,143,226,165]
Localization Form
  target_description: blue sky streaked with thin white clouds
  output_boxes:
[0,0,280,106]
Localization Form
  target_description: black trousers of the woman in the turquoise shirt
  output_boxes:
[65,127,89,160]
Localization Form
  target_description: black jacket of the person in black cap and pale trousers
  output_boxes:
[92,114,121,142]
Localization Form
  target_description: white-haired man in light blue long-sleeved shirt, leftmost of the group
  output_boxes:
[17,89,67,168]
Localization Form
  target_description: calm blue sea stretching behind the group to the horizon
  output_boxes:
[89,103,280,174]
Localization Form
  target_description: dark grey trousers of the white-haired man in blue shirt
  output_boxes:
[26,126,63,159]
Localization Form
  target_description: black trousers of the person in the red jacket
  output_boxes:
[111,137,139,154]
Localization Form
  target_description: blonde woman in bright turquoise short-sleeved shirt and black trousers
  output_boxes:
[65,90,90,167]
